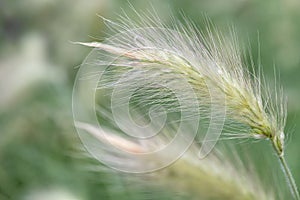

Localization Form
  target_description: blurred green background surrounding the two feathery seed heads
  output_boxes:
[0,0,300,200]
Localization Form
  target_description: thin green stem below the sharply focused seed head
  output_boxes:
[272,142,300,200]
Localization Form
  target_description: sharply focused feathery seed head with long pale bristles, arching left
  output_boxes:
[74,14,286,154]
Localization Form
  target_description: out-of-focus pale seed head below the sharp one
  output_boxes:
[76,123,275,200]
